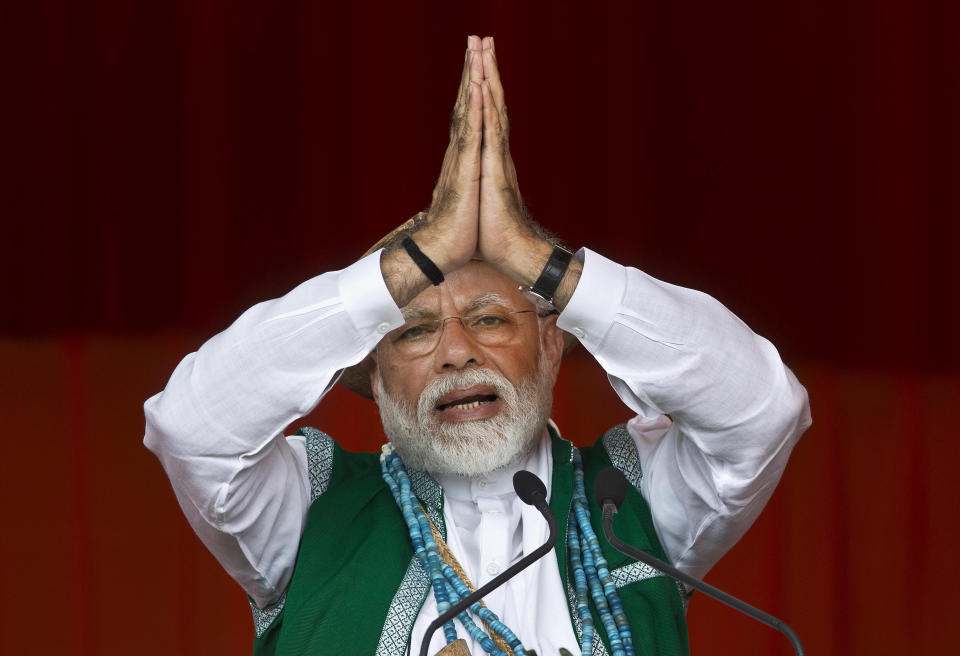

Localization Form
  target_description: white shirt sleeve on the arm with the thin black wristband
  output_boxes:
[144,251,403,607]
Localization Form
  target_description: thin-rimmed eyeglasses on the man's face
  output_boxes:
[391,310,536,358]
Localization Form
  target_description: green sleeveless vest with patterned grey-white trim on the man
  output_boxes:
[251,425,689,656]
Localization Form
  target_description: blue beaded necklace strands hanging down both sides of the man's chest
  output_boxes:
[380,444,634,656]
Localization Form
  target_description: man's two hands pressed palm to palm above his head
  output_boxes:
[385,36,568,305]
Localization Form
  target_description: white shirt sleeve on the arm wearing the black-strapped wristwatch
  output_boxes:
[557,249,811,577]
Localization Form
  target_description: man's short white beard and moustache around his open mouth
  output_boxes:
[378,354,553,476]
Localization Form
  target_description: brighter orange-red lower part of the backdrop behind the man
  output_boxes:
[0,335,960,655]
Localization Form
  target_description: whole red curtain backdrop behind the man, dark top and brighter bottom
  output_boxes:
[0,0,960,654]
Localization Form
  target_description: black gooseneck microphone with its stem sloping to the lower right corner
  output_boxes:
[593,467,805,656]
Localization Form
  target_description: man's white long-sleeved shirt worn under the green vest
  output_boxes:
[144,249,810,653]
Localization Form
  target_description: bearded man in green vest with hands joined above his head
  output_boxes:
[145,37,810,654]
